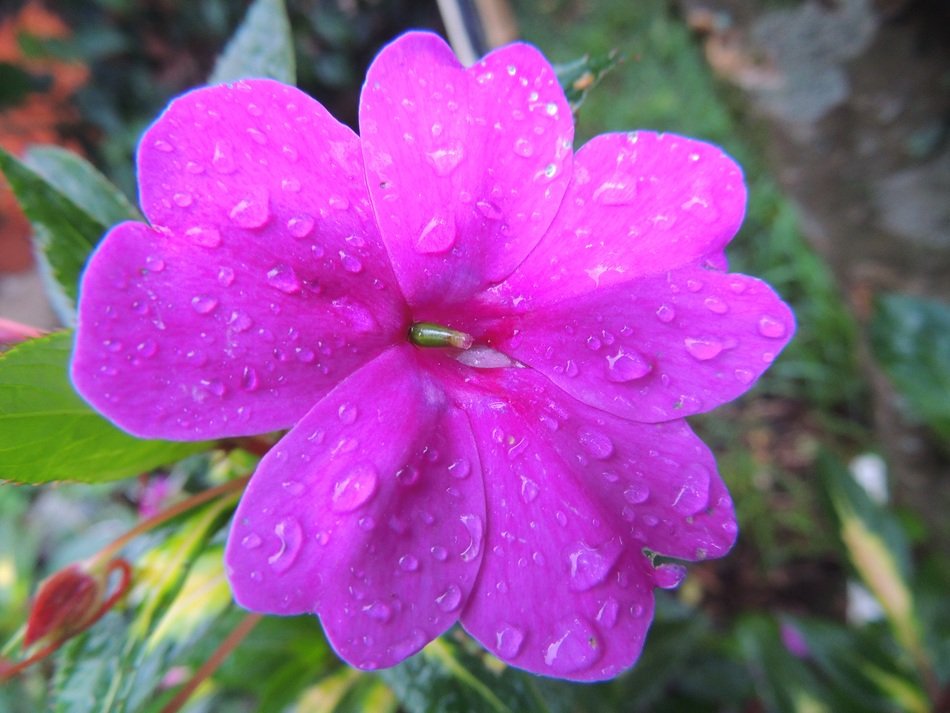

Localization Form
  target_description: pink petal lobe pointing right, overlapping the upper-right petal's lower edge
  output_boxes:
[464,267,795,423]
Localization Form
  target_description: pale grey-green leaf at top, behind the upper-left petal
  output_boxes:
[208,0,297,84]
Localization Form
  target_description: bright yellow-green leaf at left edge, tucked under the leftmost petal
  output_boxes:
[0,332,208,483]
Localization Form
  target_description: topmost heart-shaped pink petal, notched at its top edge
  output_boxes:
[360,32,574,307]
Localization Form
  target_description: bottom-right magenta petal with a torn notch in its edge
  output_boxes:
[454,369,736,680]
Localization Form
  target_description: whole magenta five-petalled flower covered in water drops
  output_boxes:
[73,33,794,680]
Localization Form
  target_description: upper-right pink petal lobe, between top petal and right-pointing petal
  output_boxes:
[502,131,746,305]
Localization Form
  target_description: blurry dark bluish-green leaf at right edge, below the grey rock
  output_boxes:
[871,294,950,446]
